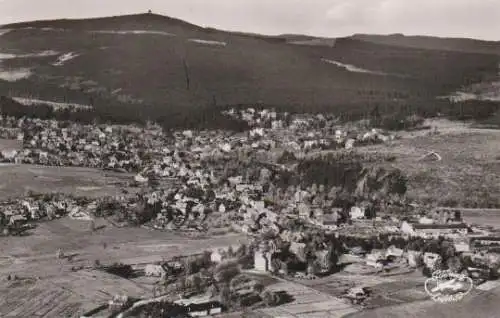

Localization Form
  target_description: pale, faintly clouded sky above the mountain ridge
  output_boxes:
[0,0,500,41]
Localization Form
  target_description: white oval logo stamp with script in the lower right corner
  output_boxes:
[424,270,474,303]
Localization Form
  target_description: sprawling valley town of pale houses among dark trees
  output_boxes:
[0,97,500,317]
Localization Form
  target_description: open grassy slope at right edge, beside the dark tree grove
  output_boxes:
[359,121,500,208]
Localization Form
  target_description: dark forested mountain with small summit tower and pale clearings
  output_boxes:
[0,14,499,128]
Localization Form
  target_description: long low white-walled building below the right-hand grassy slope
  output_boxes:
[401,221,469,237]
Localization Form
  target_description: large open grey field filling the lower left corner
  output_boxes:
[0,218,246,318]
